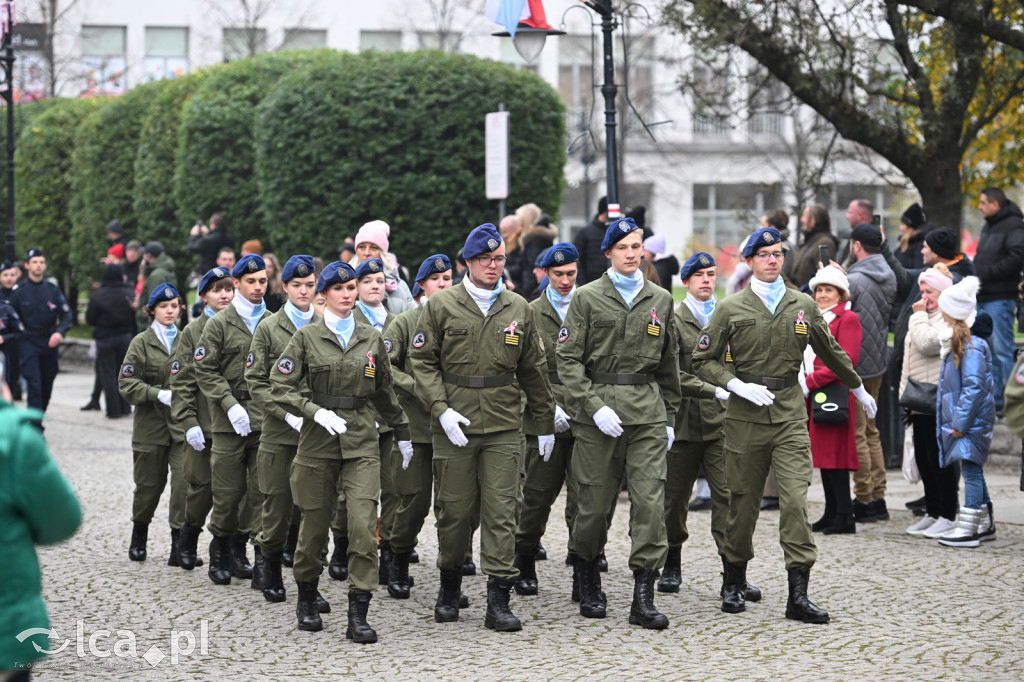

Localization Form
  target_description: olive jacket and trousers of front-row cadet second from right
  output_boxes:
[556,274,688,570]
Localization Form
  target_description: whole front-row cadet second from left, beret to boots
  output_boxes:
[409,223,555,632]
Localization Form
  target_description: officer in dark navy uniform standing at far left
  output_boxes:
[10,249,72,412]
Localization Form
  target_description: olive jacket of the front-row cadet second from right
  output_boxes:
[555,273,684,426]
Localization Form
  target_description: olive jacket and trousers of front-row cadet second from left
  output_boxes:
[409,278,555,579]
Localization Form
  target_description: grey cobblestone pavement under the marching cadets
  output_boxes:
[19,373,1024,680]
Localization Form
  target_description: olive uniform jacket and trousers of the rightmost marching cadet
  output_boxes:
[693,288,860,570]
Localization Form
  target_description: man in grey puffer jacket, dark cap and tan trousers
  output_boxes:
[847,222,896,522]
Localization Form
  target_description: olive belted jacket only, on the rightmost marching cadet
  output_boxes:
[693,287,861,424]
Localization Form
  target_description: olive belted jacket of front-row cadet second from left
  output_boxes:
[409,285,555,434]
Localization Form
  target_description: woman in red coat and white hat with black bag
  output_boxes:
[800,265,861,535]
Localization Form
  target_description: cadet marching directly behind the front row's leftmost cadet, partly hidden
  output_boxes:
[245,250,316,602]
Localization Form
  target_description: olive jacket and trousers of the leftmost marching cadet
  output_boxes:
[118,328,187,530]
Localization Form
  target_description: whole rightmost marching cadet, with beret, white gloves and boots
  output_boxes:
[693,227,877,623]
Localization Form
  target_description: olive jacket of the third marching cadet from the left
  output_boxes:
[193,301,270,433]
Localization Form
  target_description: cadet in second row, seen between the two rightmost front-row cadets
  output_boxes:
[657,251,761,601]
